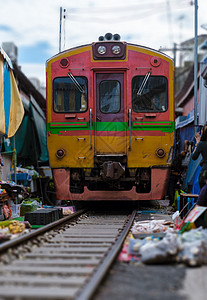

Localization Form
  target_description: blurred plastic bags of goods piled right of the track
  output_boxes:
[127,220,207,267]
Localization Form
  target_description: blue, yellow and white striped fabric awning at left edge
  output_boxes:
[0,48,24,137]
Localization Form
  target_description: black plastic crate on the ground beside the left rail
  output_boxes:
[24,208,63,225]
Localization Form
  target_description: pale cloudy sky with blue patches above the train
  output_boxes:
[0,0,207,85]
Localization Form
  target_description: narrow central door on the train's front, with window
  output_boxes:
[95,73,126,155]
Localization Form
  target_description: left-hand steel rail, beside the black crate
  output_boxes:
[0,209,87,253]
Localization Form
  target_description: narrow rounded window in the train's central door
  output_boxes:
[99,80,121,114]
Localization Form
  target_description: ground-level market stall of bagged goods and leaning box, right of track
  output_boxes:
[119,209,207,267]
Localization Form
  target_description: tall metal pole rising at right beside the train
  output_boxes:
[194,0,198,133]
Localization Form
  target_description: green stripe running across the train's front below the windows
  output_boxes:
[47,121,175,134]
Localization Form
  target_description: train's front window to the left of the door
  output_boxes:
[53,76,88,113]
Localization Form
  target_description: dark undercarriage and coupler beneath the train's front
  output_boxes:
[70,155,151,194]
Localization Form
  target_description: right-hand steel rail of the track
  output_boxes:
[76,210,136,300]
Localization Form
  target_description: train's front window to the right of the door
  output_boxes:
[132,73,168,112]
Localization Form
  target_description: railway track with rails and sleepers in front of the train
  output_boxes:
[0,211,136,300]
